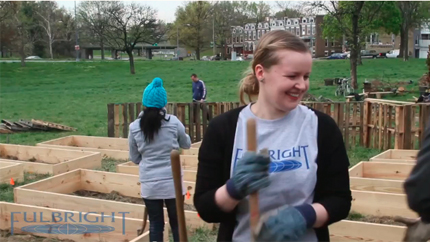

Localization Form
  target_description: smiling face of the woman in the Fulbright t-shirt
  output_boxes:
[256,50,312,112]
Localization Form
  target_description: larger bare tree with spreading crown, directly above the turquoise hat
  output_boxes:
[105,2,160,74]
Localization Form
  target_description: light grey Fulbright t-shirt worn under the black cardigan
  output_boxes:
[230,104,318,242]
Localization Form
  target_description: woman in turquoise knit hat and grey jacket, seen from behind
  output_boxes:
[128,77,191,241]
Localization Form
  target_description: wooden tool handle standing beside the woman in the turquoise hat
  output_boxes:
[170,150,188,242]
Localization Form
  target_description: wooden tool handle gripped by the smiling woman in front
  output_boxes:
[246,119,260,241]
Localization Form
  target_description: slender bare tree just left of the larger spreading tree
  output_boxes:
[79,1,109,60]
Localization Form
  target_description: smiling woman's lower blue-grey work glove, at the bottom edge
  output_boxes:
[256,204,316,241]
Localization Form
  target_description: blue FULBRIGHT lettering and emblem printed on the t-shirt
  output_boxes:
[233,145,309,173]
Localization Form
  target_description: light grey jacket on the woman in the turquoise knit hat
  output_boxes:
[128,112,191,199]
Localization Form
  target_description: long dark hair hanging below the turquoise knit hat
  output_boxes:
[140,108,170,143]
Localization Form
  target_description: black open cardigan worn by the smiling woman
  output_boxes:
[194,107,352,241]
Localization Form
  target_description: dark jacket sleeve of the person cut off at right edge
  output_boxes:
[404,117,430,223]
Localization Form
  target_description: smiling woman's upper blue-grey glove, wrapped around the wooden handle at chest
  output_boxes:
[226,151,270,200]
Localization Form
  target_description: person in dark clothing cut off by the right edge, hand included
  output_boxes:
[396,117,430,242]
